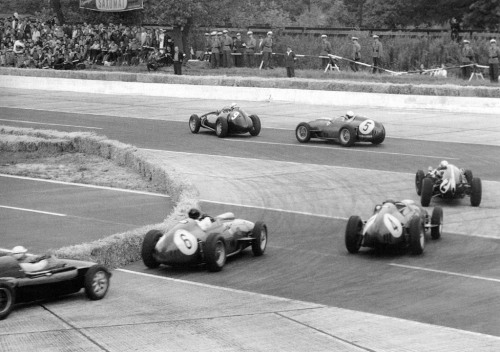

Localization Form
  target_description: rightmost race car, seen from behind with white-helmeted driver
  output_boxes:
[415,160,482,207]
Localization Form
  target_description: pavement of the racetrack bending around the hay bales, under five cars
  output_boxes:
[0,91,500,350]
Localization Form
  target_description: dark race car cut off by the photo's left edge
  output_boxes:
[0,255,111,320]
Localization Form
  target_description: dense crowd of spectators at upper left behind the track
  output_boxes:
[0,13,178,69]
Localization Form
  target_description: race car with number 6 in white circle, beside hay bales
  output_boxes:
[141,209,268,272]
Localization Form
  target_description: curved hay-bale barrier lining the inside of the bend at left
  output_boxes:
[0,126,199,268]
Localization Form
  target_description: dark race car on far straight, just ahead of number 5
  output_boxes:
[189,103,261,138]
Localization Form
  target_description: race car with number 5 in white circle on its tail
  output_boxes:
[295,111,385,147]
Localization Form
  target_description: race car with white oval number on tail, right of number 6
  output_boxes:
[345,200,443,255]
